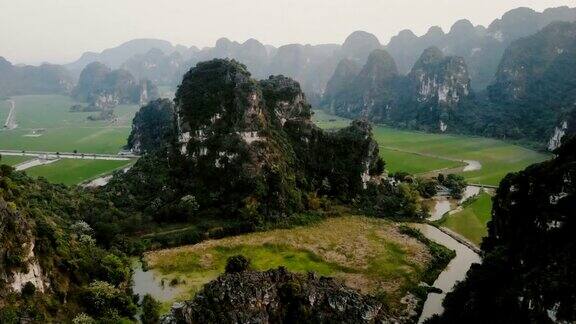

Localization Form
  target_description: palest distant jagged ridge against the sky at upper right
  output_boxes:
[386,7,576,91]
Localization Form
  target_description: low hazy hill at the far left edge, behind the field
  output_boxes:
[0,57,74,97]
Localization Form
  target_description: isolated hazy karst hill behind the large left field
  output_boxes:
[73,62,158,110]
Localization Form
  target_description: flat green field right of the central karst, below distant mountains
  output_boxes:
[314,110,551,185]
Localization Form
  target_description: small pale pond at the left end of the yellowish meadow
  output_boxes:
[132,261,181,302]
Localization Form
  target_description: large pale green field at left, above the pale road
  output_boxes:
[0,95,139,154]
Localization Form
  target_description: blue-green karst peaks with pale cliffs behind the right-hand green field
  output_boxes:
[324,47,472,132]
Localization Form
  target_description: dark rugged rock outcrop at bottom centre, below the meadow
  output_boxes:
[161,267,391,324]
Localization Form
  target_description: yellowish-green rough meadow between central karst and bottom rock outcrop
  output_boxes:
[145,216,450,314]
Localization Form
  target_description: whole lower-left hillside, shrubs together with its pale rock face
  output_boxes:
[0,165,136,323]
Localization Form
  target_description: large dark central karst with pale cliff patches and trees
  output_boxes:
[176,60,379,218]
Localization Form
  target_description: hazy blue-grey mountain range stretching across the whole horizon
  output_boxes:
[0,7,576,147]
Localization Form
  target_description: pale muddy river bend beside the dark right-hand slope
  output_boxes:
[412,224,481,323]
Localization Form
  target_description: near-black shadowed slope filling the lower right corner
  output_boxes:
[433,136,576,323]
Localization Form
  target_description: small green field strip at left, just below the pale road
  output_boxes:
[26,159,131,185]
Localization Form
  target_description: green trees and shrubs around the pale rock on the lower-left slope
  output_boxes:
[0,167,131,323]
